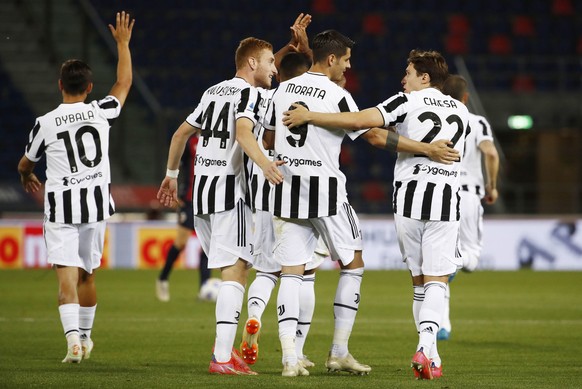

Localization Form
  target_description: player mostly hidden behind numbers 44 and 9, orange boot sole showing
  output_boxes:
[240,50,329,367]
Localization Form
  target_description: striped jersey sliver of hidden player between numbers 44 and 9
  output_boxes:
[249,88,275,211]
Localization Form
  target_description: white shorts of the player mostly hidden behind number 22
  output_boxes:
[459,190,483,271]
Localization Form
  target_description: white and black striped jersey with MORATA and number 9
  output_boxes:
[265,72,365,219]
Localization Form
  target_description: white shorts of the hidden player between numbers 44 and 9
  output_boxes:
[253,209,329,273]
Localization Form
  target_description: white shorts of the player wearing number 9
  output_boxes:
[273,203,362,269]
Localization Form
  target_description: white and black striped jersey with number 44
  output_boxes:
[186,77,261,215]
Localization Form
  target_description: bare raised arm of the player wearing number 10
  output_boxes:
[109,11,135,106]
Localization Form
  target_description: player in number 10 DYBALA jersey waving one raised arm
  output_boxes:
[18,12,135,363]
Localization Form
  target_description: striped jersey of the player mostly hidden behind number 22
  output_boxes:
[461,113,493,198]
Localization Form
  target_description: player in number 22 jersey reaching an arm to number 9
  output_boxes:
[284,50,469,379]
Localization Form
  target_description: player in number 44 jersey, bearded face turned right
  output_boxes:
[158,37,283,375]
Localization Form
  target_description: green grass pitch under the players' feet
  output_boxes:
[0,270,582,389]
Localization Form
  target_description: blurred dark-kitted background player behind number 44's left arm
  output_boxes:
[156,134,211,302]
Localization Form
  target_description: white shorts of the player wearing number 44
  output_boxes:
[194,200,254,269]
